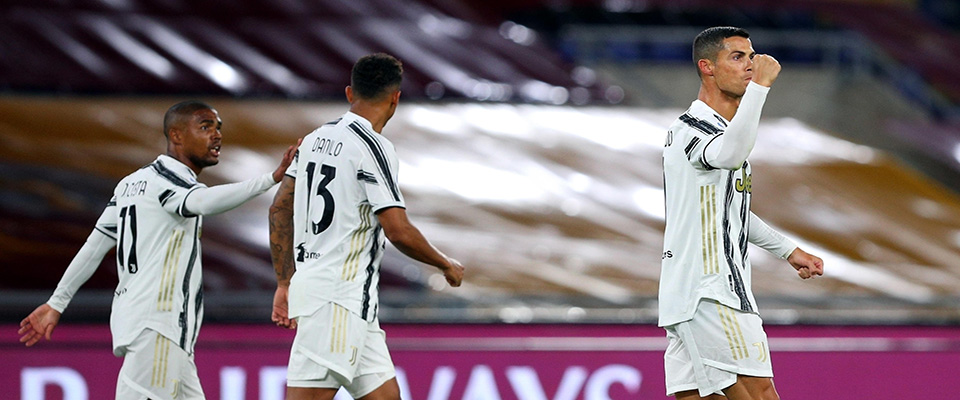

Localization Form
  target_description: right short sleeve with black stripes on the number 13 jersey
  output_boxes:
[357,146,406,212]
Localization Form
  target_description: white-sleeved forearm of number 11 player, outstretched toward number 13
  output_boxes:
[183,173,276,215]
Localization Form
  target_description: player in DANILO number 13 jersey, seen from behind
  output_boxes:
[270,53,463,400]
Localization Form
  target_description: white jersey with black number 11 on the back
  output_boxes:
[96,155,205,355]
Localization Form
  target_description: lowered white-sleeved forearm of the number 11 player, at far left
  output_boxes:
[47,230,116,313]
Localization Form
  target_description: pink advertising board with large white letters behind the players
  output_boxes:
[0,324,960,400]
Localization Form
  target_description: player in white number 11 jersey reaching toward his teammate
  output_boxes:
[19,101,295,399]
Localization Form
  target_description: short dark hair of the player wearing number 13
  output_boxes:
[350,53,403,100]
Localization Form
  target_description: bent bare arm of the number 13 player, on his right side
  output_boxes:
[377,207,463,287]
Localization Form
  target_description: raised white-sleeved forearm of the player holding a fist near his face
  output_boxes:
[704,82,770,170]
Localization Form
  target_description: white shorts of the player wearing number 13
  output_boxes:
[287,303,396,398]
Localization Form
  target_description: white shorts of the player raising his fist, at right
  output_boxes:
[663,299,773,397]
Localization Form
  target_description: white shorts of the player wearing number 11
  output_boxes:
[117,329,204,400]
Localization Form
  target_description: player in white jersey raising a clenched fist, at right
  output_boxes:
[659,27,823,400]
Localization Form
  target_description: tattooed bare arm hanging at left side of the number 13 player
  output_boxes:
[270,176,296,329]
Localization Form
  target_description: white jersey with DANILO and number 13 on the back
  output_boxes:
[287,112,404,321]
